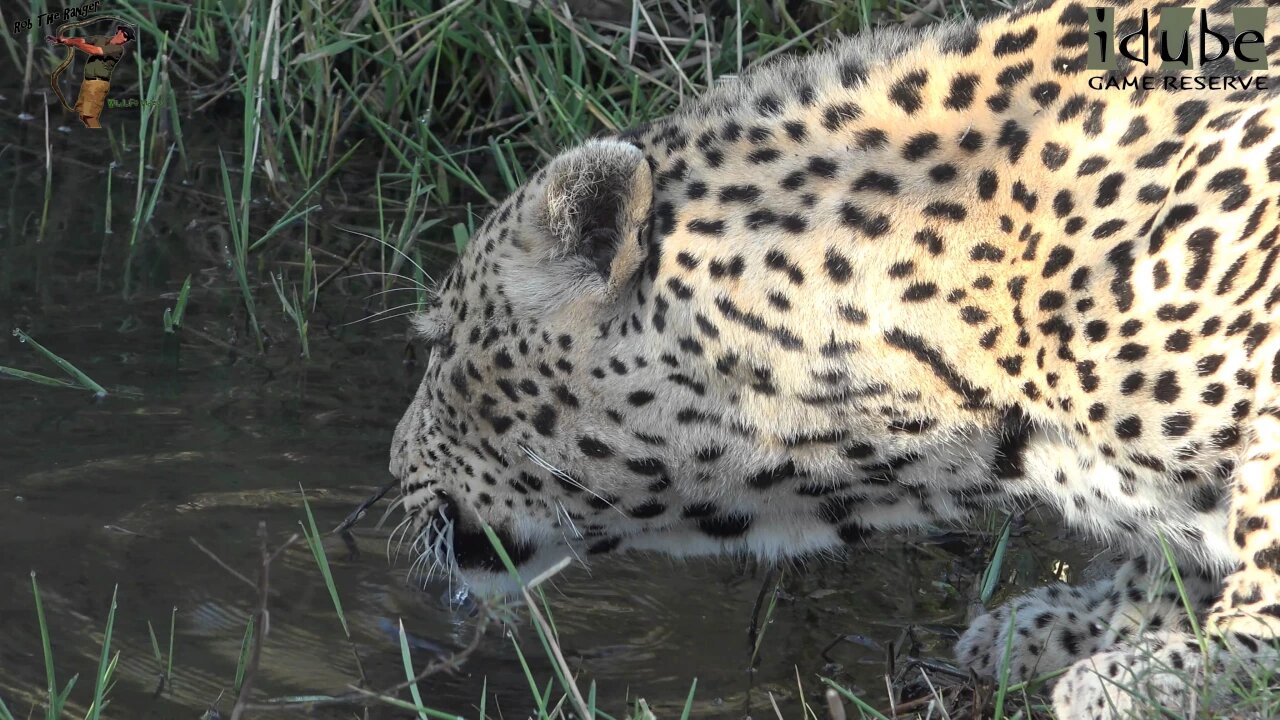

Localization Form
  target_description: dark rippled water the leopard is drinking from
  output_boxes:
[0,94,1080,719]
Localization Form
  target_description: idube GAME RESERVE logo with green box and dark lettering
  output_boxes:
[1085,8,1267,90]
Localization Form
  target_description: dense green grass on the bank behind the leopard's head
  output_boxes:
[15,0,995,357]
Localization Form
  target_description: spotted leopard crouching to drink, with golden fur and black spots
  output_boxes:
[390,0,1280,719]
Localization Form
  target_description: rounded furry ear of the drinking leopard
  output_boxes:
[545,140,653,292]
